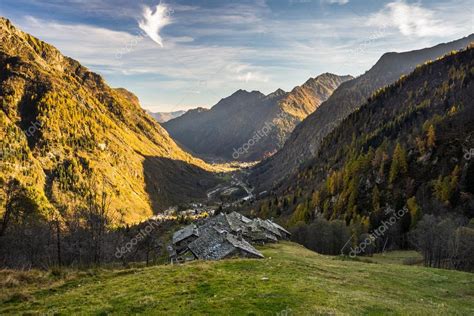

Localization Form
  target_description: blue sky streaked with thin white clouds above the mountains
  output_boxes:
[0,0,474,112]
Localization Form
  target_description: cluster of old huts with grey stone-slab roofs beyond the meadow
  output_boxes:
[168,212,291,263]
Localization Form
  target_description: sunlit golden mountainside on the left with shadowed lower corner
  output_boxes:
[0,18,221,222]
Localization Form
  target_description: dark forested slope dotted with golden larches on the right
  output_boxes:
[257,44,474,227]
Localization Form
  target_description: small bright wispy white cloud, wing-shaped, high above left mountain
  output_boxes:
[138,3,172,47]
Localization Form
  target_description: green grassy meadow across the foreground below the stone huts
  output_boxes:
[0,242,474,315]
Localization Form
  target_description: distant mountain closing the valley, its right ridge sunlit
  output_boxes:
[163,73,351,161]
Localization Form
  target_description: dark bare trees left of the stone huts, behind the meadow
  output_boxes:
[0,179,177,269]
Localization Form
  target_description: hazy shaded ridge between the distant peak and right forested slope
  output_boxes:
[250,34,474,191]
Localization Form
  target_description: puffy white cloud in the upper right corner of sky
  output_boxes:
[368,0,457,37]
